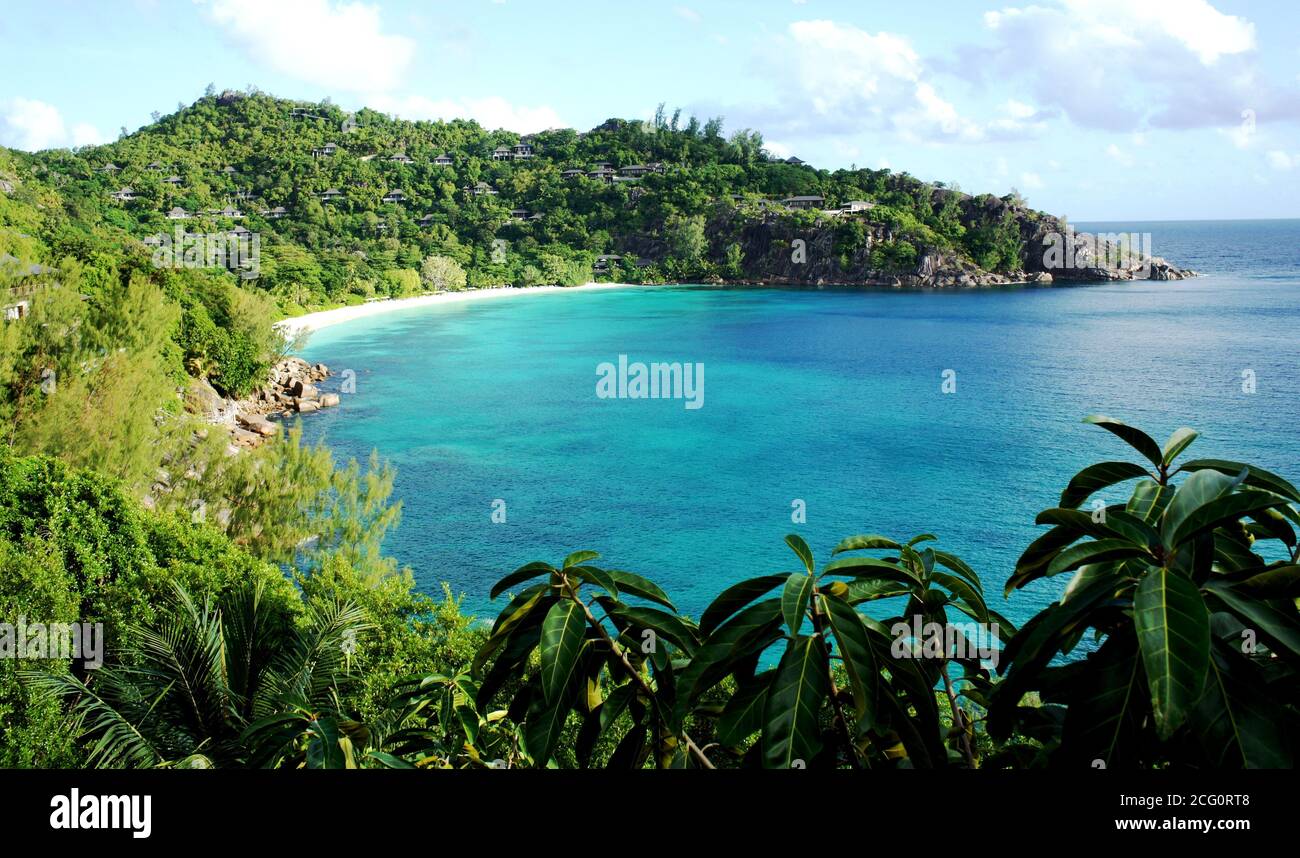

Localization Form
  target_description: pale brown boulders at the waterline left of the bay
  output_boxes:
[186,358,339,449]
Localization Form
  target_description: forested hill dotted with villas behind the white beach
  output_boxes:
[0,92,1190,312]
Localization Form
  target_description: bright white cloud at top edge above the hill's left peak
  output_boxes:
[208,0,415,92]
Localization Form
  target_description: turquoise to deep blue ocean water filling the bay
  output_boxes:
[303,221,1300,621]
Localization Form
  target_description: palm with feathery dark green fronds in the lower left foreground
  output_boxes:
[25,581,369,768]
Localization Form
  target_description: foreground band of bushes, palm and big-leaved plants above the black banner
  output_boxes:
[0,417,1300,768]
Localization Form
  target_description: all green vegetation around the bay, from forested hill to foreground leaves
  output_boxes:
[0,91,1279,768]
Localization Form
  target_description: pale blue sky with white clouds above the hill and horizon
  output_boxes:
[0,0,1300,221]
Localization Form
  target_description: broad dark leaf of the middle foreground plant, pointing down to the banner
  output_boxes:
[762,636,829,768]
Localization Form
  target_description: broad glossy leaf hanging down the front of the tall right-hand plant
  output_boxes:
[1134,567,1210,738]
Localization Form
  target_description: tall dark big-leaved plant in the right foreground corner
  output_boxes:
[989,417,1300,768]
